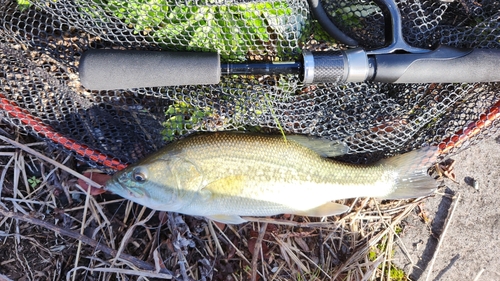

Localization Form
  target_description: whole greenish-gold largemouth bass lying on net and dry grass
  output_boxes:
[105,132,437,224]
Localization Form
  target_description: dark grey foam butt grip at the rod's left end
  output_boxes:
[79,50,221,90]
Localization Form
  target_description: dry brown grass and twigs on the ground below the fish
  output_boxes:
[0,125,430,280]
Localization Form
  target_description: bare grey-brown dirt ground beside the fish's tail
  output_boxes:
[394,133,500,281]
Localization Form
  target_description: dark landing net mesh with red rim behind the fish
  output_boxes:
[0,0,500,167]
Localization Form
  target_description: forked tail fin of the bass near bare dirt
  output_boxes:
[381,146,438,199]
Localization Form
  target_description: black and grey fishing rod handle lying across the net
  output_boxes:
[79,0,500,90]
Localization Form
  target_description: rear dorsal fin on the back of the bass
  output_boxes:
[286,135,349,157]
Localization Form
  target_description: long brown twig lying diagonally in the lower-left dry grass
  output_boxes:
[0,208,174,276]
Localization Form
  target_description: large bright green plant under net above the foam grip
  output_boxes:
[92,0,305,61]
